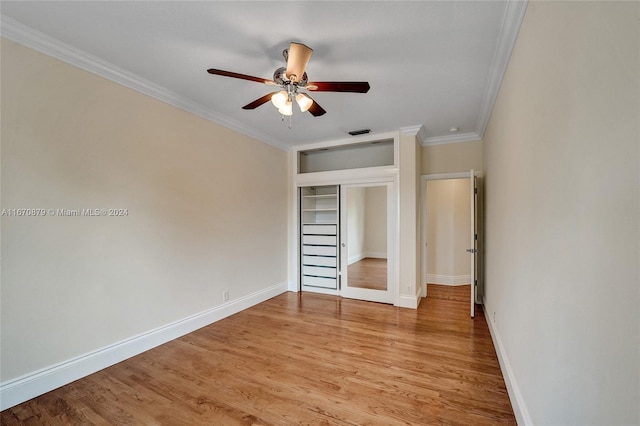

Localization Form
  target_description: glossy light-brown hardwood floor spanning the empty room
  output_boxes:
[0,286,515,426]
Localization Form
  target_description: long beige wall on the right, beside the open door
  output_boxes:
[484,2,640,425]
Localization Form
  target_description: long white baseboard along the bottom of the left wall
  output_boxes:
[0,282,287,411]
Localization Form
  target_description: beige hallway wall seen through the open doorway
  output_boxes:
[426,179,471,284]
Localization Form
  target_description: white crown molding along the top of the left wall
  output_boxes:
[0,15,289,151]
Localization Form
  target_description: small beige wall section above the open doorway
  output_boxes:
[421,141,482,175]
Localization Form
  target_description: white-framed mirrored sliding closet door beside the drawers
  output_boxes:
[340,182,396,304]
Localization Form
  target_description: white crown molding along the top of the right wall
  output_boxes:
[475,0,528,139]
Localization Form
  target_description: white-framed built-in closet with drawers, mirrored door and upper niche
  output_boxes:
[293,132,398,303]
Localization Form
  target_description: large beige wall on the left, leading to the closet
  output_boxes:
[1,40,287,381]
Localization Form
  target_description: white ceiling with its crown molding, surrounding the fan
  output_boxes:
[0,0,526,149]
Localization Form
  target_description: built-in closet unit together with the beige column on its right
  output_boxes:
[288,126,424,309]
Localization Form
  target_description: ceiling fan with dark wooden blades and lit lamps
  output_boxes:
[207,43,369,117]
